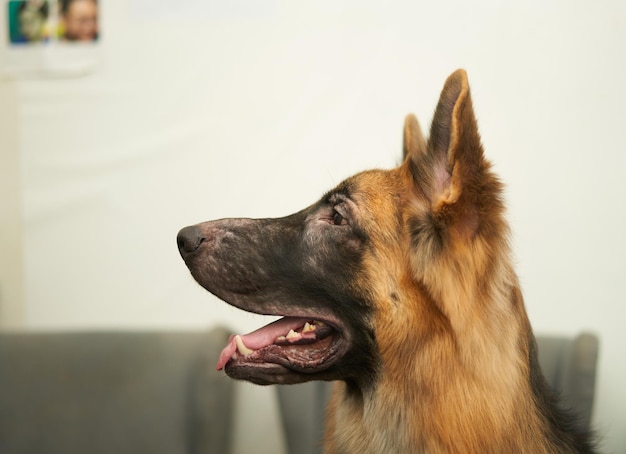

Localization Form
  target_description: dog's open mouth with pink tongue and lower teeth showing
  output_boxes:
[217,317,345,381]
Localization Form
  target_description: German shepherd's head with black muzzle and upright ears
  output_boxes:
[178,70,521,388]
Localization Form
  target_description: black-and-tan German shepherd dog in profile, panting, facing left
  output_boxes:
[178,70,593,454]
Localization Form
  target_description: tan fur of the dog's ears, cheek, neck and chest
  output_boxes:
[325,71,576,454]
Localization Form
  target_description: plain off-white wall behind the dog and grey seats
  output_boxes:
[6,0,626,453]
